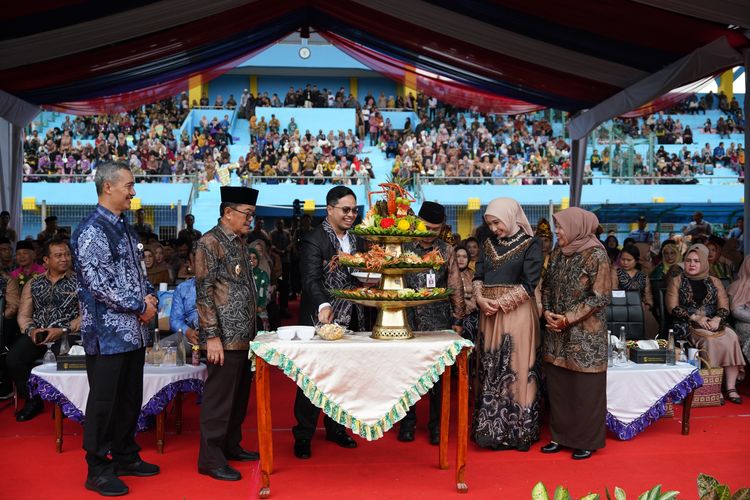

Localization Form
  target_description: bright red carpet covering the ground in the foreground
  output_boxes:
[0,298,750,500]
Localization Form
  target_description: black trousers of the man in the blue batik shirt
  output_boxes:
[83,349,146,477]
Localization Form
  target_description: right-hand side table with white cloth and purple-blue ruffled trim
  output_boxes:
[607,361,703,440]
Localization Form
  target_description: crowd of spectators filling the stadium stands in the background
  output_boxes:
[24,84,745,186]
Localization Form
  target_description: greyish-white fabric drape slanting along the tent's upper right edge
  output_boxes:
[568,37,743,140]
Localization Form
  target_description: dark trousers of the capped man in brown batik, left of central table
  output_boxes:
[198,349,251,469]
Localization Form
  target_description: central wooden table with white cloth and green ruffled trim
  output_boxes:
[250,330,473,498]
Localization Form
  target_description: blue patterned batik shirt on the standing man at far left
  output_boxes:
[70,205,154,355]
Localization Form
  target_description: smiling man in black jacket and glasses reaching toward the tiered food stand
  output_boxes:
[292,186,365,459]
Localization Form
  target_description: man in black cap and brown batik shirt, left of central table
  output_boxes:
[195,186,258,481]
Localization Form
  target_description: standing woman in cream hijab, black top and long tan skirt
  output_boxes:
[473,198,543,451]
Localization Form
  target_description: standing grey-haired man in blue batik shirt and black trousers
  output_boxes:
[71,162,159,496]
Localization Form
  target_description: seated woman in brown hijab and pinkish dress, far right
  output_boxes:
[665,244,745,404]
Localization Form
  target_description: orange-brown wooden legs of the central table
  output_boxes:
[255,348,469,498]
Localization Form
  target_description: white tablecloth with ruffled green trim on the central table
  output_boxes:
[250,331,473,440]
